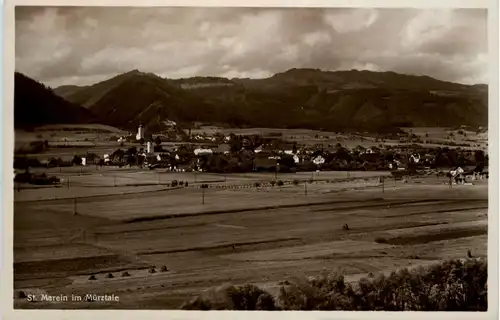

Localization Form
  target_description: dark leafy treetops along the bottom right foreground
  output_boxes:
[181,259,488,311]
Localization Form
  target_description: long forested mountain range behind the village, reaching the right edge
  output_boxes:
[56,69,488,131]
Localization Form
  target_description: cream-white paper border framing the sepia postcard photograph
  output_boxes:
[0,0,499,320]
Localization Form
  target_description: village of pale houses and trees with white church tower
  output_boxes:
[14,123,488,188]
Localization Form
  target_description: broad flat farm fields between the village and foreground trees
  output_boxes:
[14,168,488,309]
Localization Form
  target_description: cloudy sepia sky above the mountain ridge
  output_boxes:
[15,7,488,87]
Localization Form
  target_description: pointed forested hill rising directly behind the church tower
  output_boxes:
[69,70,216,131]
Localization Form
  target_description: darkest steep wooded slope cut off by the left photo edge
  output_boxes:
[14,72,96,129]
